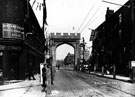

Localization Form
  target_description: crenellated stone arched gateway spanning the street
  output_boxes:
[50,33,80,67]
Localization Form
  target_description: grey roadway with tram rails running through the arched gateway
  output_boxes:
[49,70,135,97]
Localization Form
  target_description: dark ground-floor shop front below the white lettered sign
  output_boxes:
[0,45,43,82]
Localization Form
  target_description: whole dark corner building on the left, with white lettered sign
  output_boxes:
[0,0,46,79]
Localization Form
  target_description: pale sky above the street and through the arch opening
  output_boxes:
[30,0,128,59]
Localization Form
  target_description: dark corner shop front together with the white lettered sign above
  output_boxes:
[0,23,44,81]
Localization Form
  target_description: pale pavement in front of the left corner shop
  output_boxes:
[0,75,45,97]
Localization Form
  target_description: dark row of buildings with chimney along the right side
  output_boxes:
[91,1,135,76]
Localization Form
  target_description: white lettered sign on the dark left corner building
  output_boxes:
[2,23,24,39]
